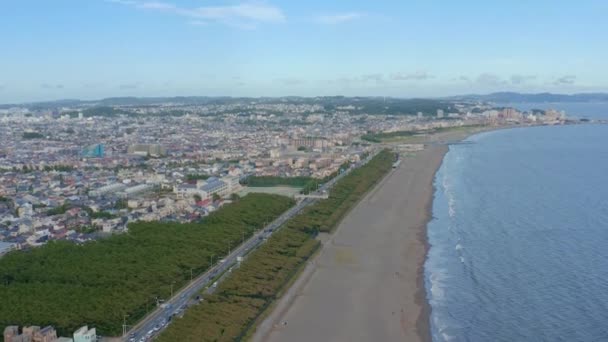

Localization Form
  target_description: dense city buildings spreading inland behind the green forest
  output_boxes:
[0,98,565,255]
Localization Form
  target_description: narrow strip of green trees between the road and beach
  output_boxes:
[157,151,394,342]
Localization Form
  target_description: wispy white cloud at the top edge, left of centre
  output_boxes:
[106,0,286,29]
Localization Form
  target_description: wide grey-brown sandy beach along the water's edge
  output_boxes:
[252,132,490,342]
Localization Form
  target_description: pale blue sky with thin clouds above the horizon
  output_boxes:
[0,0,608,103]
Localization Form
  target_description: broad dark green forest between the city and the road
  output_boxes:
[0,194,294,336]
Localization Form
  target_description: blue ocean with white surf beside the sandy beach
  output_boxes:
[425,105,608,342]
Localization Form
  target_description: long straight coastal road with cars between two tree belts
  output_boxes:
[123,151,378,342]
